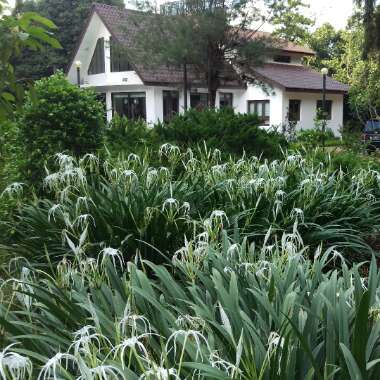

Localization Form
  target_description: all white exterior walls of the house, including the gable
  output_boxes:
[68,13,343,135]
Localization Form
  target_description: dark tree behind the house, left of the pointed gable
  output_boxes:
[14,0,124,80]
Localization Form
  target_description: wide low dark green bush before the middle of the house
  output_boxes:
[156,108,287,158]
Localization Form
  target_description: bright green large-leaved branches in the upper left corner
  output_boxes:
[0,0,61,120]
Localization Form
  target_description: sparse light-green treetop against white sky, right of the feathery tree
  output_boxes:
[270,0,314,43]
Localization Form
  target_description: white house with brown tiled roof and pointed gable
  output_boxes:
[68,4,348,134]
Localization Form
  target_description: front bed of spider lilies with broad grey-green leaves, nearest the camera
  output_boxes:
[0,211,380,380]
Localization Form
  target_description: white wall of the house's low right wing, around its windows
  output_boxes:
[282,92,343,136]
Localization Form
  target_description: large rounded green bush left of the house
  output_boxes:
[19,72,104,183]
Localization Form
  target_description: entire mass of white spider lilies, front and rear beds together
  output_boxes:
[0,145,380,380]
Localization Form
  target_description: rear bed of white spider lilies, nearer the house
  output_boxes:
[2,144,380,266]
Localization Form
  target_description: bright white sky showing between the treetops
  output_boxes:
[9,0,353,29]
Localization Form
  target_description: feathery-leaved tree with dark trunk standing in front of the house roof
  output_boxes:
[137,0,282,107]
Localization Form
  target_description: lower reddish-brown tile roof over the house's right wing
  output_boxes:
[252,63,349,93]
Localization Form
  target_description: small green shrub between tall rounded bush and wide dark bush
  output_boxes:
[104,115,158,156]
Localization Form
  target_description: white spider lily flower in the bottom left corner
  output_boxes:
[0,344,33,380]
